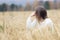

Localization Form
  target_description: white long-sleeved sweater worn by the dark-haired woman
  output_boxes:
[26,13,54,32]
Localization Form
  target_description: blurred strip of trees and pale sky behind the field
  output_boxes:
[0,0,60,11]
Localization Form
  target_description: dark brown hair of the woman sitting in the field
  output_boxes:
[35,6,47,21]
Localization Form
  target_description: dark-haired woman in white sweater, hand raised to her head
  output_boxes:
[26,6,54,31]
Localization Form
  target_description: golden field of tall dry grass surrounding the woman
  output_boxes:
[0,10,60,40]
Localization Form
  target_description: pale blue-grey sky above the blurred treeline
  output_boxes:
[0,0,59,5]
